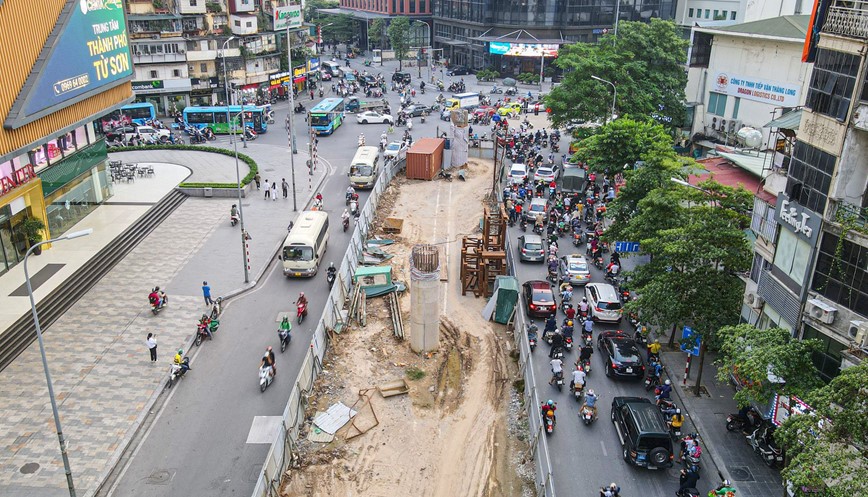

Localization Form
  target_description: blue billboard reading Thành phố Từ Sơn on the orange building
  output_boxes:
[4,0,133,128]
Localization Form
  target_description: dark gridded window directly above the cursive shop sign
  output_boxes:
[787,140,837,212]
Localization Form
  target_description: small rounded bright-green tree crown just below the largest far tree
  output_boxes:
[575,117,674,173]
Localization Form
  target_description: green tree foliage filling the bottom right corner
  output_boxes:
[775,362,868,497]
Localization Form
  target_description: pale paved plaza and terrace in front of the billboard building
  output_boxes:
[0,144,327,497]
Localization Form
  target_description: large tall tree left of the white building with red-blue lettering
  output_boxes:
[545,19,688,127]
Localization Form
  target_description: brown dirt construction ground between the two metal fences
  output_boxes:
[282,159,533,497]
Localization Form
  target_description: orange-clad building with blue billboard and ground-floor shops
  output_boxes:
[0,0,133,274]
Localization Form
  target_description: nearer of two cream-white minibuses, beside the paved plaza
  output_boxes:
[280,211,329,278]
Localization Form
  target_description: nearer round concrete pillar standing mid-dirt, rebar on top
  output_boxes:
[410,245,440,353]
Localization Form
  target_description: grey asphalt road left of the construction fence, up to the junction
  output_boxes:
[111,57,482,497]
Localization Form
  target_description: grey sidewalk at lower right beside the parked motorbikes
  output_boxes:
[660,348,784,497]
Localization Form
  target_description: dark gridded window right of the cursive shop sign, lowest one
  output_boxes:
[811,231,868,317]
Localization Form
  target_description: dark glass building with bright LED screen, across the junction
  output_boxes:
[434,0,676,71]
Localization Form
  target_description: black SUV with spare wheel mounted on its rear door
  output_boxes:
[612,397,673,469]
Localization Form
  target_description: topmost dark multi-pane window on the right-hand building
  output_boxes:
[805,48,859,121]
